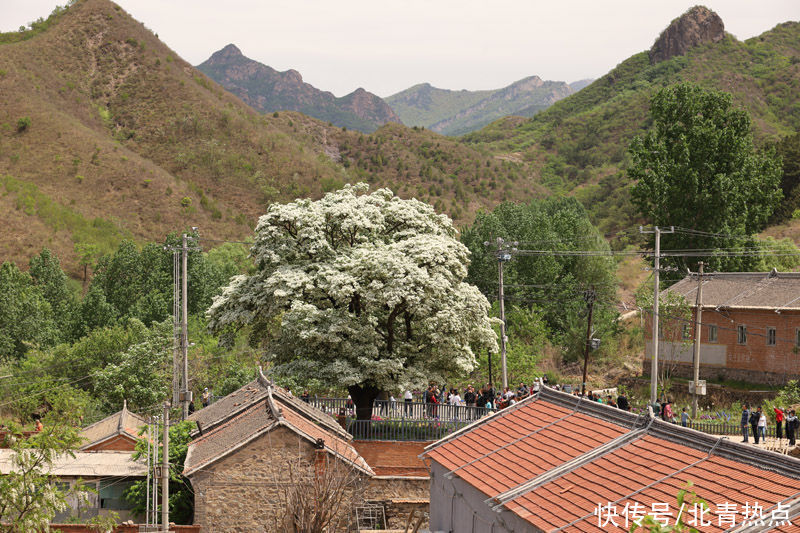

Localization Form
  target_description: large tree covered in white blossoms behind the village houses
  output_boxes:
[208,184,497,419]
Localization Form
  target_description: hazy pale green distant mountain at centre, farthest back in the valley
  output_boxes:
[386,76,574,135]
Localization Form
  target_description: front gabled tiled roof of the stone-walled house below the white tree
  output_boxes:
[183,384,374,476]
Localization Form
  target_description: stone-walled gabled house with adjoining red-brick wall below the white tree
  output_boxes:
[183,374,429,532]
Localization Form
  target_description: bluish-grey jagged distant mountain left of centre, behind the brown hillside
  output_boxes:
[197,44,400,133]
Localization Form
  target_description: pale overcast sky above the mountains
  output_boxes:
[0,0,800,96]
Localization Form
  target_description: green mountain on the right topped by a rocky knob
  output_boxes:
[462,6,800,232]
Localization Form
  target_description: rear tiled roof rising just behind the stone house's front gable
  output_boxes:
[188,370,351,439]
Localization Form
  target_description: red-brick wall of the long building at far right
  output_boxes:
[643,308,800,384]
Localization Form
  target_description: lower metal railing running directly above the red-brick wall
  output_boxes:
[347,418,472,441]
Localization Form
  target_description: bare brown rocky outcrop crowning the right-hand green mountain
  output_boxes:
[650,6,725,64]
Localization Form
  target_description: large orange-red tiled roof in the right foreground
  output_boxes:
[423,387,800,532]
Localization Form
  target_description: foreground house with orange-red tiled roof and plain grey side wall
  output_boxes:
[423,387,800,533]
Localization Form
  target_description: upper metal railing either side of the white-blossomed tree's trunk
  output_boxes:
[308,397,489,420]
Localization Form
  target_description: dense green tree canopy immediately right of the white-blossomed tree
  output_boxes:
[462,198,616,358]
